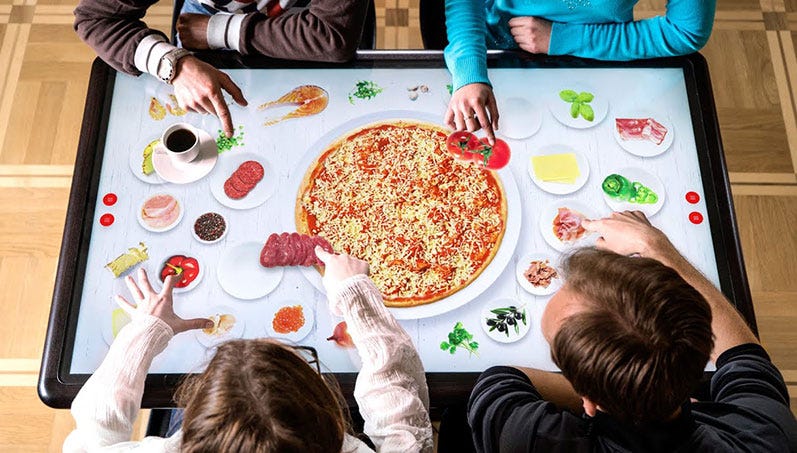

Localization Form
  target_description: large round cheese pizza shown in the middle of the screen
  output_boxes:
[295,120,507,307]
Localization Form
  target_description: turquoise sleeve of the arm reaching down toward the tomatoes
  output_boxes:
[444,0,490,91]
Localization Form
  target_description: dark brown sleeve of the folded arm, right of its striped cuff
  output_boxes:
[239,0,367,62]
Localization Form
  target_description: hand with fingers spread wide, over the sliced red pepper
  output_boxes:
[116,268,213,334]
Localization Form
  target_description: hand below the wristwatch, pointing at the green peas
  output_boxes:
[172,55,247,138]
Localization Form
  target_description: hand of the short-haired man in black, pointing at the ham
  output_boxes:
[581,211,677,260]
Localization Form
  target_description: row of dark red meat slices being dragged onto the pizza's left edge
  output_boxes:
[260,233,335,267]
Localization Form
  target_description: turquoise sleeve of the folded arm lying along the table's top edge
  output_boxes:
[548,0,716,60]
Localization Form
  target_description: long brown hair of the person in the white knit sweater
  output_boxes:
[175,339,347,453]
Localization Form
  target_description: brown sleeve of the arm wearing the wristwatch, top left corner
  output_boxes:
[74,0,165,75]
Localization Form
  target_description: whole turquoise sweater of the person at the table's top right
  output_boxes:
[445,0,716,89]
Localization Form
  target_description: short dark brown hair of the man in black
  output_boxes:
[551,249,714,424]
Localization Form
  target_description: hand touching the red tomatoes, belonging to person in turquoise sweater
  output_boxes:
[445,83,498,145]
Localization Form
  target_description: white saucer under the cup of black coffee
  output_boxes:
[152,129,219,184]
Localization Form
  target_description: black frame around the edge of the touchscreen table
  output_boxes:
[38,51,757,408]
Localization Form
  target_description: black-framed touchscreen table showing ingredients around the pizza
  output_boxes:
[39,52,755,407]
